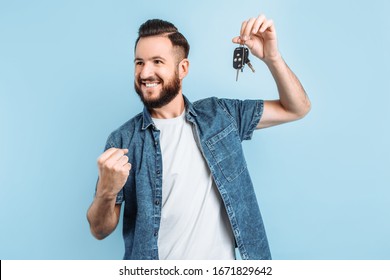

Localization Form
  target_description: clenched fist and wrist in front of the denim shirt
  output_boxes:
[97,148,131,198]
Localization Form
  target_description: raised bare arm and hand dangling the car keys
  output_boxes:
[233,15,311,128]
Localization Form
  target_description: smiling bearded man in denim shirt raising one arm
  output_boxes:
[87,15,310,259]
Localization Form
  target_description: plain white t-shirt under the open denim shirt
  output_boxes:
[153,111,235,260]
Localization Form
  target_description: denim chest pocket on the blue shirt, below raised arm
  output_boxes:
[206,123,246,182]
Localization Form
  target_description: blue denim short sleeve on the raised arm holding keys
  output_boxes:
[219,99,264,141]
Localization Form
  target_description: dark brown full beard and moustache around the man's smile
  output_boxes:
[134,71,181,109]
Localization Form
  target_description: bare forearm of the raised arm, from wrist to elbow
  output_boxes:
[266,55,311,119]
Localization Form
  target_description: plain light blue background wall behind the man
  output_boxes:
[0,0,390,259]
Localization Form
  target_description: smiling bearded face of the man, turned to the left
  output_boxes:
[134,36,181,109]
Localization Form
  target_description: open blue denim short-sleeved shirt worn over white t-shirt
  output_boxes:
[105,97,271,260]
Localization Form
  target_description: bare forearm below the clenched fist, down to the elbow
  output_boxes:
[87,183,119,240]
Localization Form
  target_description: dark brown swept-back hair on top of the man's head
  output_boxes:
[134,19,190,58]
